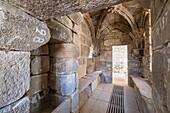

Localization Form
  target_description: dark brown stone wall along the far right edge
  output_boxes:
[151,0,170,113]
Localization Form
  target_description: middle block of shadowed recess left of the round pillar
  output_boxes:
[31,56,49,75]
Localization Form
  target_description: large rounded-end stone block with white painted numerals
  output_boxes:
[0,2,50,50]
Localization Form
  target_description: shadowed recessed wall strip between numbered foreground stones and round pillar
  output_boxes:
[28,44,50,110]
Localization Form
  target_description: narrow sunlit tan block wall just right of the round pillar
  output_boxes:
[78,20,93,78]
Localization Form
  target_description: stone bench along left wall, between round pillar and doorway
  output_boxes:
[79,71,102,108]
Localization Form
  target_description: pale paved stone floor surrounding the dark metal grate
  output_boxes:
[80,77,140,113]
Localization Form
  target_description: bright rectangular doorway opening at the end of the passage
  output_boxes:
[112,45,128,85]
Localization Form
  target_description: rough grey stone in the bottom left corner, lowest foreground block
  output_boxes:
[0,97,30,113]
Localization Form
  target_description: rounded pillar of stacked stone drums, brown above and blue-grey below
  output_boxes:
[48,13,81,113]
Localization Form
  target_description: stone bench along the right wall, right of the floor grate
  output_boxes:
[131,76,154,113]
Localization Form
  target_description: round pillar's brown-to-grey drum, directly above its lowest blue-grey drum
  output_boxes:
[50,58,78,74]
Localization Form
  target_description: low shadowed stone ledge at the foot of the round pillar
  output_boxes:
[30,94,70,113]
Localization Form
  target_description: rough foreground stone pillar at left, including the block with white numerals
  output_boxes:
[0,2,50,113]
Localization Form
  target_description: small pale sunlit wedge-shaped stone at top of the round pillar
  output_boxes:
[55,16,73,29]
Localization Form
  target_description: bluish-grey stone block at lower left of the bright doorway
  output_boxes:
[101,71,112,83]
